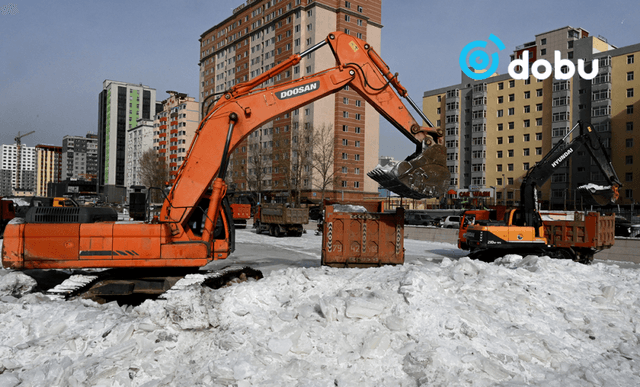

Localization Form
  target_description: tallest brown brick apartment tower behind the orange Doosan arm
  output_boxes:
[200,0,382,200]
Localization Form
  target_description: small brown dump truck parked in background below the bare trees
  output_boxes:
[253,203,309,237]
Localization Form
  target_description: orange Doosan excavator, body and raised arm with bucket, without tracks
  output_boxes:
[2,32,449,276]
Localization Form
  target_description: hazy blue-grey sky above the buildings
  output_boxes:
[0,0,640,159]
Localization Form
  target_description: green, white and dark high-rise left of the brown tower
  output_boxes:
[98,80,156,185]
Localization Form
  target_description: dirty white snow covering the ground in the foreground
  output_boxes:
[0,230,640,387]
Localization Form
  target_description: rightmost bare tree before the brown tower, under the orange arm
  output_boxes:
[311,124,338,202]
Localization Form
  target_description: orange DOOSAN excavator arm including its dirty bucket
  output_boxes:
[160,32,449,246]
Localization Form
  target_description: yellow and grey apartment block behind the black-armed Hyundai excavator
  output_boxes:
[423,27,640,208]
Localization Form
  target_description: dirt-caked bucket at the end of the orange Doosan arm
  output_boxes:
[367,145,450,199]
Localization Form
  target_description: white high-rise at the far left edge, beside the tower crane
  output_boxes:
[0,144,36,196]
